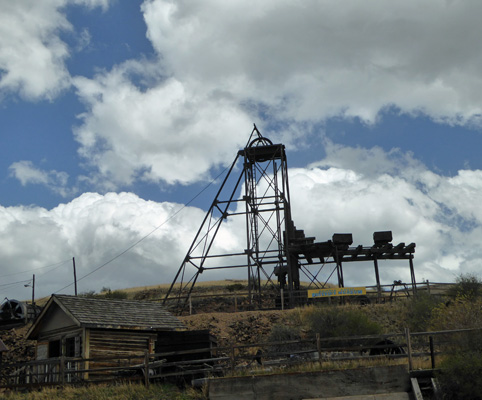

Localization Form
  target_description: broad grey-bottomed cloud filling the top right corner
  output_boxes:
[143,0,482,123]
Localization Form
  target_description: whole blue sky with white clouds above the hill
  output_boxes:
[0,0,482,299]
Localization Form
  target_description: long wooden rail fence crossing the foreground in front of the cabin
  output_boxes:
[0,329,482,389]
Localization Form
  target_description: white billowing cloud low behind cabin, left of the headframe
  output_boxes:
[0,193,203,298]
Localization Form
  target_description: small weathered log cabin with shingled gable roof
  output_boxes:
[27,295,186,382]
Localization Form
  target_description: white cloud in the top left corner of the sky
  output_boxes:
[0,0,109,100]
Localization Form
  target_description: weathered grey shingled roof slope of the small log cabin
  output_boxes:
[52,295,186,330]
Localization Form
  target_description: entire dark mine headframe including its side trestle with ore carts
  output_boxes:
[164,126,416,309]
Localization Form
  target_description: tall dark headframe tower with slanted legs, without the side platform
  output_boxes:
[164,125,299,310]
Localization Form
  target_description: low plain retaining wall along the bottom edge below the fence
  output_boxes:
[209,365,410,400]
